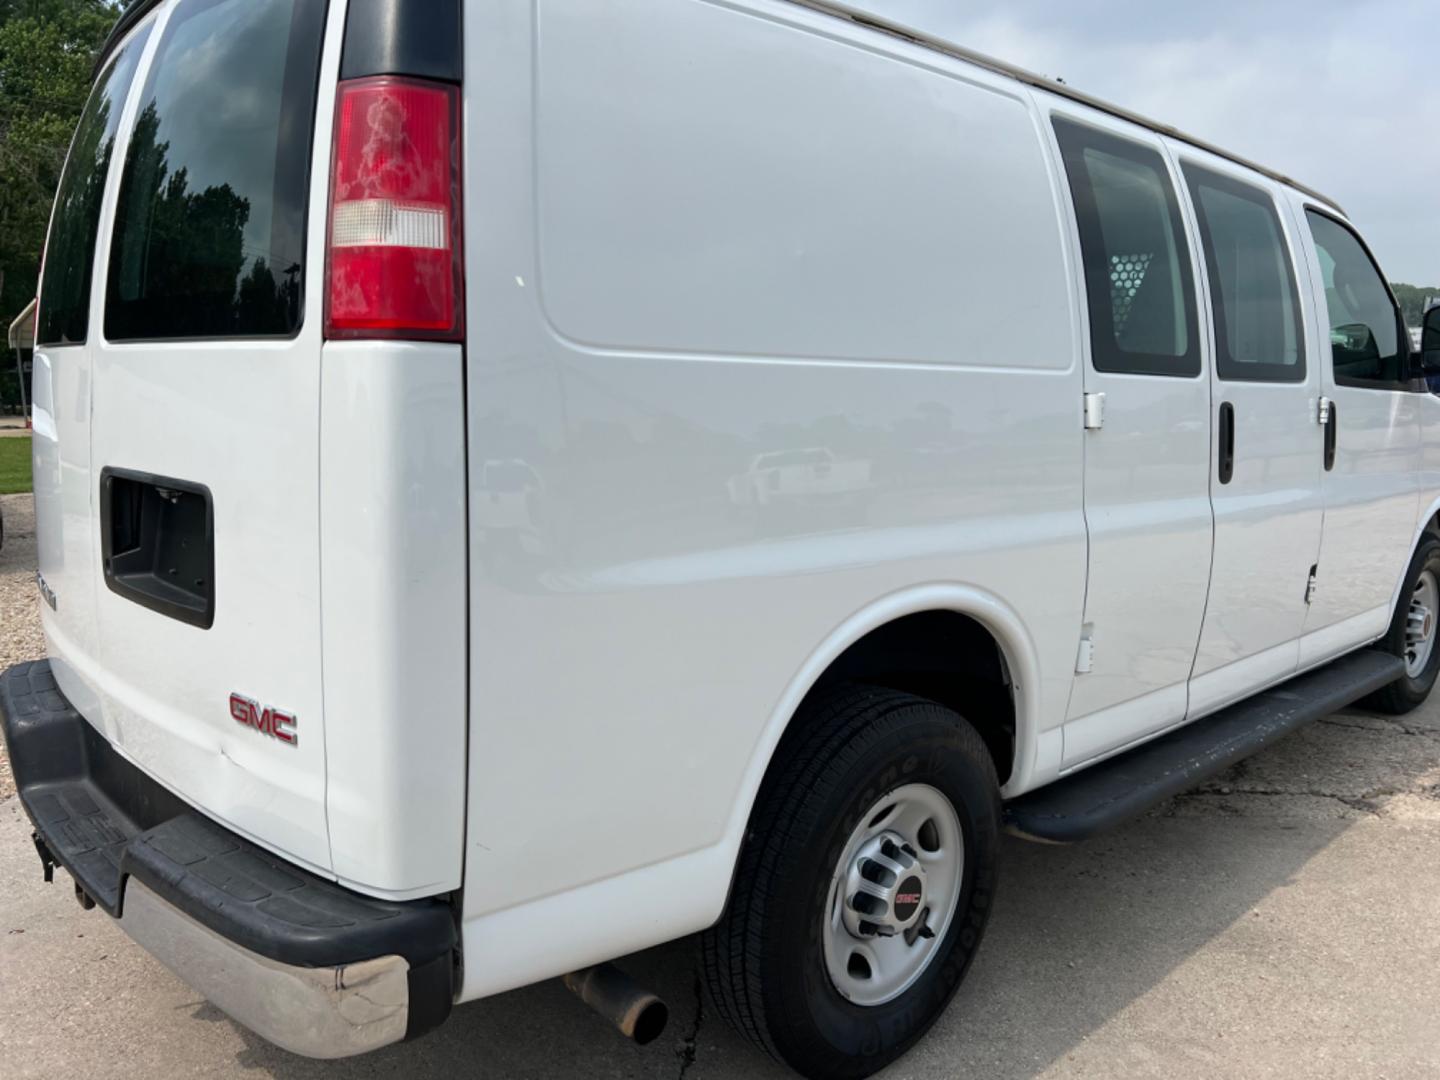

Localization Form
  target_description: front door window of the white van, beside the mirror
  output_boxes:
[1306,210,1408,389]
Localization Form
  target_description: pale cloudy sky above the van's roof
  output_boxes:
[850,0,1440,285]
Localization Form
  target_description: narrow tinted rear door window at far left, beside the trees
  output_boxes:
[35,26,150,346]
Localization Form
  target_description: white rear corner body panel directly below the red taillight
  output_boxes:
[320,341,467,900]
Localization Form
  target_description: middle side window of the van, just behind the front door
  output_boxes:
[1185,166,1305,383]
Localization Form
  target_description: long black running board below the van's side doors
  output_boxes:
[1005,649,1405,844]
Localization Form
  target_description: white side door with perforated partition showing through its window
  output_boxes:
[1053,107,1211,766]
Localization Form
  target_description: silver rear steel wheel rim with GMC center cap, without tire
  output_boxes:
[824,783,965,1005]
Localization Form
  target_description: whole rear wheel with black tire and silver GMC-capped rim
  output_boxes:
[703,687,999,1077]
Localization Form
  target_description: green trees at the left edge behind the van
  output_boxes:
[0,0,122,324]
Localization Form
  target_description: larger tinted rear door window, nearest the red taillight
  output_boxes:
[105,0,325,341]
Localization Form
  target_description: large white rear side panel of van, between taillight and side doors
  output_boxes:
[464,0,1084,996]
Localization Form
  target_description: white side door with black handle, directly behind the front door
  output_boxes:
[1169,143,1322,717]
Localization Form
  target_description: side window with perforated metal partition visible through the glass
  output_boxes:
[1054,117,1200,376]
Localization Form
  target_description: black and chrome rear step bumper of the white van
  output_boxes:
[0,661,456,1057]
